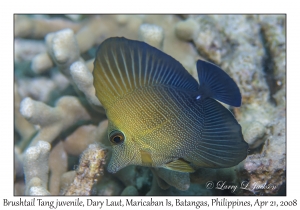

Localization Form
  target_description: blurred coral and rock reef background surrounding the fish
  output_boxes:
[14,15,286,195]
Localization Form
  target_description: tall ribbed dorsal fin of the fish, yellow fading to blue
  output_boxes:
[93,37,199,107]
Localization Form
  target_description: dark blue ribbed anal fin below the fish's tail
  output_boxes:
[188,98,248,168]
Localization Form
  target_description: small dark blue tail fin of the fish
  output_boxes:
[197,60,242,107]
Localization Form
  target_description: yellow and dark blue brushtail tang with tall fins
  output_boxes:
[93,37,248,173]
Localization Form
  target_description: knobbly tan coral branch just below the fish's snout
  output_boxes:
[65,144,107,195]
